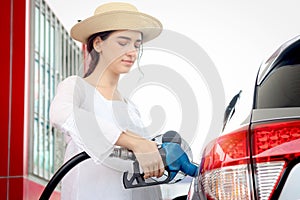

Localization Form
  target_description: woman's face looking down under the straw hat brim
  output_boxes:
[100,30,142,74]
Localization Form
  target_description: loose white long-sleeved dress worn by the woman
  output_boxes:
[50,76,161,200]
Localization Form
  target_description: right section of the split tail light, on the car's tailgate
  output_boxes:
[252,121,300,200]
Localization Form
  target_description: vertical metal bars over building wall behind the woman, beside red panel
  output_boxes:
[29,0,83,180]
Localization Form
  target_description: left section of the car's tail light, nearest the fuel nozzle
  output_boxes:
[199,127,250,200]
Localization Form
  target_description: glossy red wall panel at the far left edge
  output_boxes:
[0,0,59,200]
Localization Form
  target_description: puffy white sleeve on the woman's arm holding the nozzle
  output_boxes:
[50,77,124,163]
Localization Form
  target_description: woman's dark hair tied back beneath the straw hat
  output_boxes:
[83,31,114,78]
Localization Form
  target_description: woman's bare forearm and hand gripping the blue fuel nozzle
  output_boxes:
[116,132,165,179]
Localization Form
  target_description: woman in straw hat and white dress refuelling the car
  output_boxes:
[50,3,164,200]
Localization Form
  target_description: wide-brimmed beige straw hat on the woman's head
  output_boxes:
[71,2,162,43]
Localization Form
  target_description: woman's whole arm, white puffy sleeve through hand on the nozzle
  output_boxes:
[50,77,164,178]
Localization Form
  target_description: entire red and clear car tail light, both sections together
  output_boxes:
[199,121,300,200]
